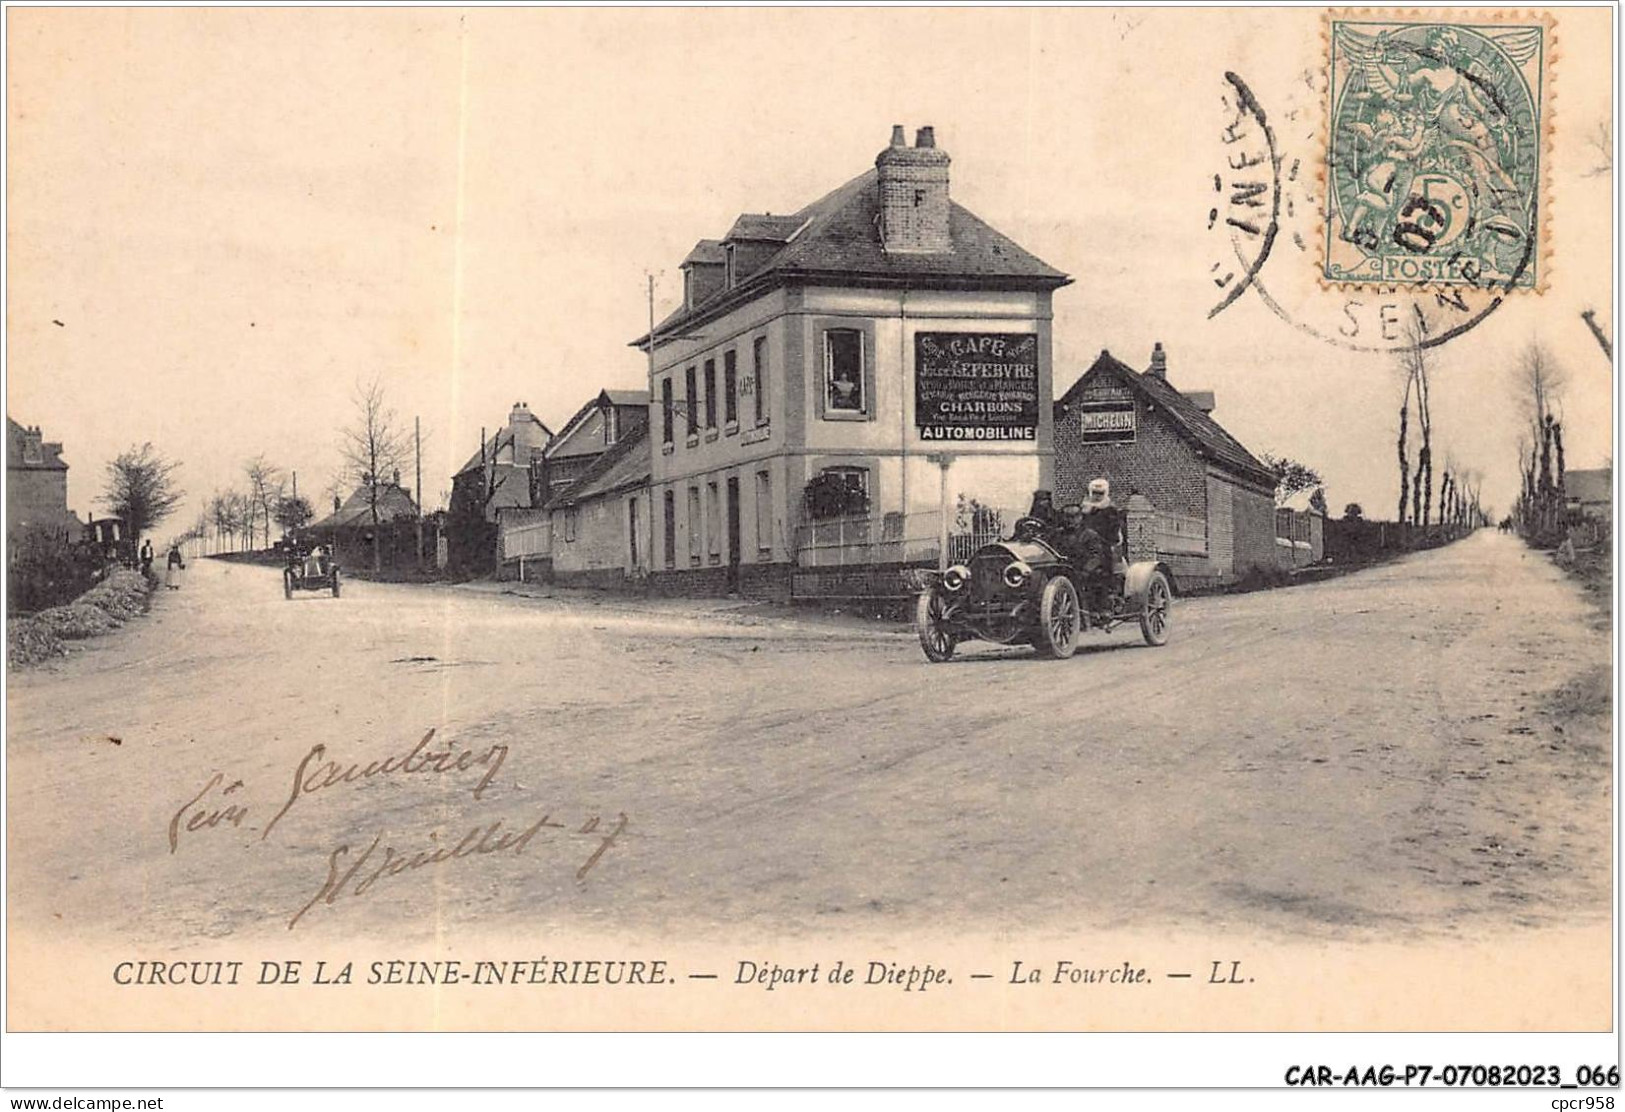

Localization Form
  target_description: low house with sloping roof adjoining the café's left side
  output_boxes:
[546,423,653,587]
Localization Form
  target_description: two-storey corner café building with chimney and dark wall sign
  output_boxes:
[634,127,1069,598]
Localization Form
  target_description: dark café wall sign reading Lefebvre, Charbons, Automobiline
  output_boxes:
[915,332,1038,441]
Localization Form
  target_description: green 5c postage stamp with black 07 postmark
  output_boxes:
[1321,11,1554,291]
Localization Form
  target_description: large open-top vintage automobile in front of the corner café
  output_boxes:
[915,519,1173,663]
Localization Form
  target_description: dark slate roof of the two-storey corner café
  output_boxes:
[632,169,1071,348]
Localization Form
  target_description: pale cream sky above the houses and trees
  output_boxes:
[7,8,1615,532]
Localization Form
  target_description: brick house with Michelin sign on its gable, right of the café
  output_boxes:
[1055,343,1280,589]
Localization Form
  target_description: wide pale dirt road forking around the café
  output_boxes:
[7,532,1610,941]
